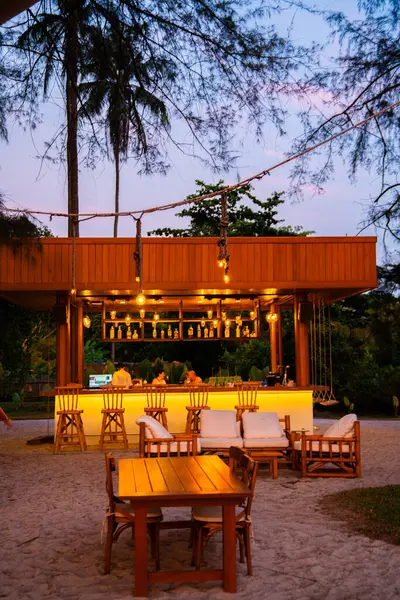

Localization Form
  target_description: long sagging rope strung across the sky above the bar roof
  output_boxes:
[0,100,400,219]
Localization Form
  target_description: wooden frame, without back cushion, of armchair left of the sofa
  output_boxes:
[139,423,197,458]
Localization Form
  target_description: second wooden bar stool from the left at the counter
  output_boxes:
[100,385,128,450]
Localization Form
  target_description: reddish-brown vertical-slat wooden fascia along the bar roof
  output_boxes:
[0,237,377,291]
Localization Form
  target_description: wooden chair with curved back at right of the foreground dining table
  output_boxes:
[192,447,258,575]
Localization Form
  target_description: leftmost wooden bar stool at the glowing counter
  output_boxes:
[54,383,87,452]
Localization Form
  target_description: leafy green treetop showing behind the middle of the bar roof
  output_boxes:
[148,179,313,237]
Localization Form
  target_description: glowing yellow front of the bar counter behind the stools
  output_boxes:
[48,385,320,446]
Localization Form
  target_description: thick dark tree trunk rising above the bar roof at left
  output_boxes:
[65,9,79,237]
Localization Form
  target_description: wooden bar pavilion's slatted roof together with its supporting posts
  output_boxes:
[0,237,377,386]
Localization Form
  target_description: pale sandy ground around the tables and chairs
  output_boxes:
[0,421,400,600]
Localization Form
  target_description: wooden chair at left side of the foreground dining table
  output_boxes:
[104,452,163,575]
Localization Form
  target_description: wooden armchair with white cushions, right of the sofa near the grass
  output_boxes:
[293,415,361,478]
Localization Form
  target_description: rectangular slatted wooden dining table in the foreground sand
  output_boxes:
[118,455,250,596]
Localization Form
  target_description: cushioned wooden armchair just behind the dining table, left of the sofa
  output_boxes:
[136,417,200,458]
